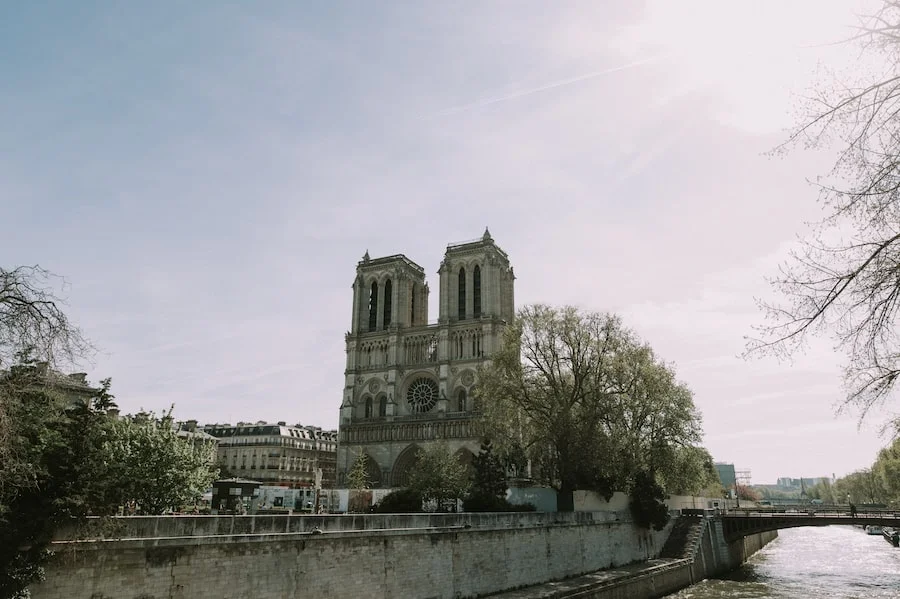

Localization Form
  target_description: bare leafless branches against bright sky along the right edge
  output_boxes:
[748,0,900,426]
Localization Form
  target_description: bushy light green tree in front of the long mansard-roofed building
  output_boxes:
[105,409,218,514]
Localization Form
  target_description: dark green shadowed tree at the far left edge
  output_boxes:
[0,364,113,597]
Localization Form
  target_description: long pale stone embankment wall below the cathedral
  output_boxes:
[31,512,669,599]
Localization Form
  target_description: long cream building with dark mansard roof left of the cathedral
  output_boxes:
[203,422,337,489]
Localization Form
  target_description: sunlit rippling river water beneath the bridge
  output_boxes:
[669,526,900,599]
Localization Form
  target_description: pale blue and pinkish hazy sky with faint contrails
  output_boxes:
[0,0,888,483]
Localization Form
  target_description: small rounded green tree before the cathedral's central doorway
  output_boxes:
[409,443,471,510]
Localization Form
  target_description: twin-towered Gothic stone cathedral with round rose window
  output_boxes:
[337,229,515,488]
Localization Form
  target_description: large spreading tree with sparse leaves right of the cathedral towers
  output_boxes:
[478,305,701,511]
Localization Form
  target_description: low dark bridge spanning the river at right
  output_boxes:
[720,505,900,542]
